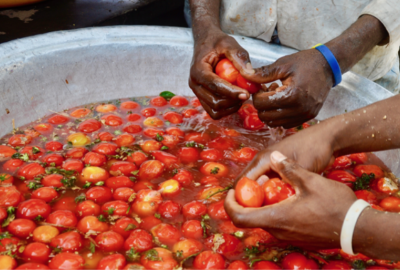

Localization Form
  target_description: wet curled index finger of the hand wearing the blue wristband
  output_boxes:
[253,86,297,111]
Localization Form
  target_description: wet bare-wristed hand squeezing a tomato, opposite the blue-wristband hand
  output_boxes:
[189,30,252,119]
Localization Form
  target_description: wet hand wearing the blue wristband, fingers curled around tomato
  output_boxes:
[241,49,334,128]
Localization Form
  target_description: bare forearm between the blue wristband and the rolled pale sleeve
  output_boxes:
[326,15,388,73]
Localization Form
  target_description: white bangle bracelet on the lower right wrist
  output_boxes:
[340,200,371,255]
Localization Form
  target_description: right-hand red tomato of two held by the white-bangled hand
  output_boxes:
[262,178,295,205]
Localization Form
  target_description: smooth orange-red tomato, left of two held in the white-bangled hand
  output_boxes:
[235,177,265,207]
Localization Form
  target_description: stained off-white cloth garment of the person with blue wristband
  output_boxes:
[220,0,400,83]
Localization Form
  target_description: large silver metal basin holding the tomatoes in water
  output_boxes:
[0,26,400,175]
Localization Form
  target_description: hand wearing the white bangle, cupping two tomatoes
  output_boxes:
[225,151,357,249]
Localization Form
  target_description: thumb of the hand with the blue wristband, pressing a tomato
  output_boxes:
[240,63,288,84]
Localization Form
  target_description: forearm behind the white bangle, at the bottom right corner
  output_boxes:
[353,208,400,261]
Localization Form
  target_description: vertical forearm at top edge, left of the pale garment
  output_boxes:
[190,0,221,43]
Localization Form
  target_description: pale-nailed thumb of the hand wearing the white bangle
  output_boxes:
[271,151,310,193]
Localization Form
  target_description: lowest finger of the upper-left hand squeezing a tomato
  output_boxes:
[189,81,241,111]
